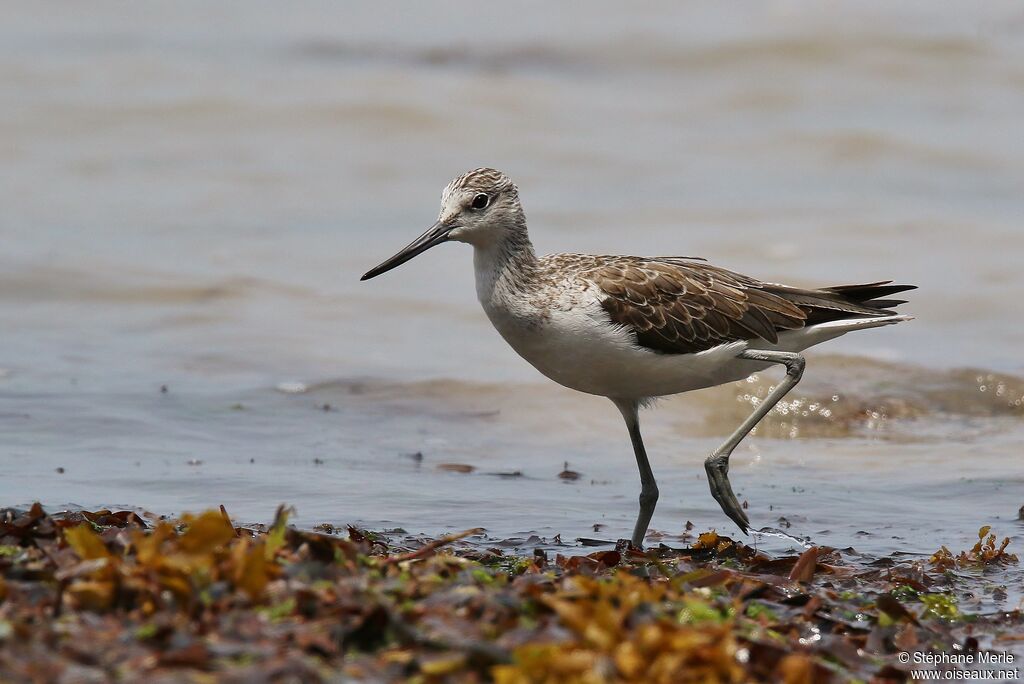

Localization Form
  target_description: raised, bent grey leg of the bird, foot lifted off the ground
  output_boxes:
[705,349,805,535]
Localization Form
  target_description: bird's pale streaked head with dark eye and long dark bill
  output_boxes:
[359,168,526,281]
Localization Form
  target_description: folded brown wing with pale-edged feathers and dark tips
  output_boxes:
[586,257,913,354]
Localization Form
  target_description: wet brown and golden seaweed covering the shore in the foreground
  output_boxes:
[0,504,1024,684]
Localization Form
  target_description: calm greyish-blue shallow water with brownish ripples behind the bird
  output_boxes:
[0,2,1024,569]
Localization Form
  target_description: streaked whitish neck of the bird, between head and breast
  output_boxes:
[473,227,538,308]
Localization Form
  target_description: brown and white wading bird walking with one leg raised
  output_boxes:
[360,168,914,547]
